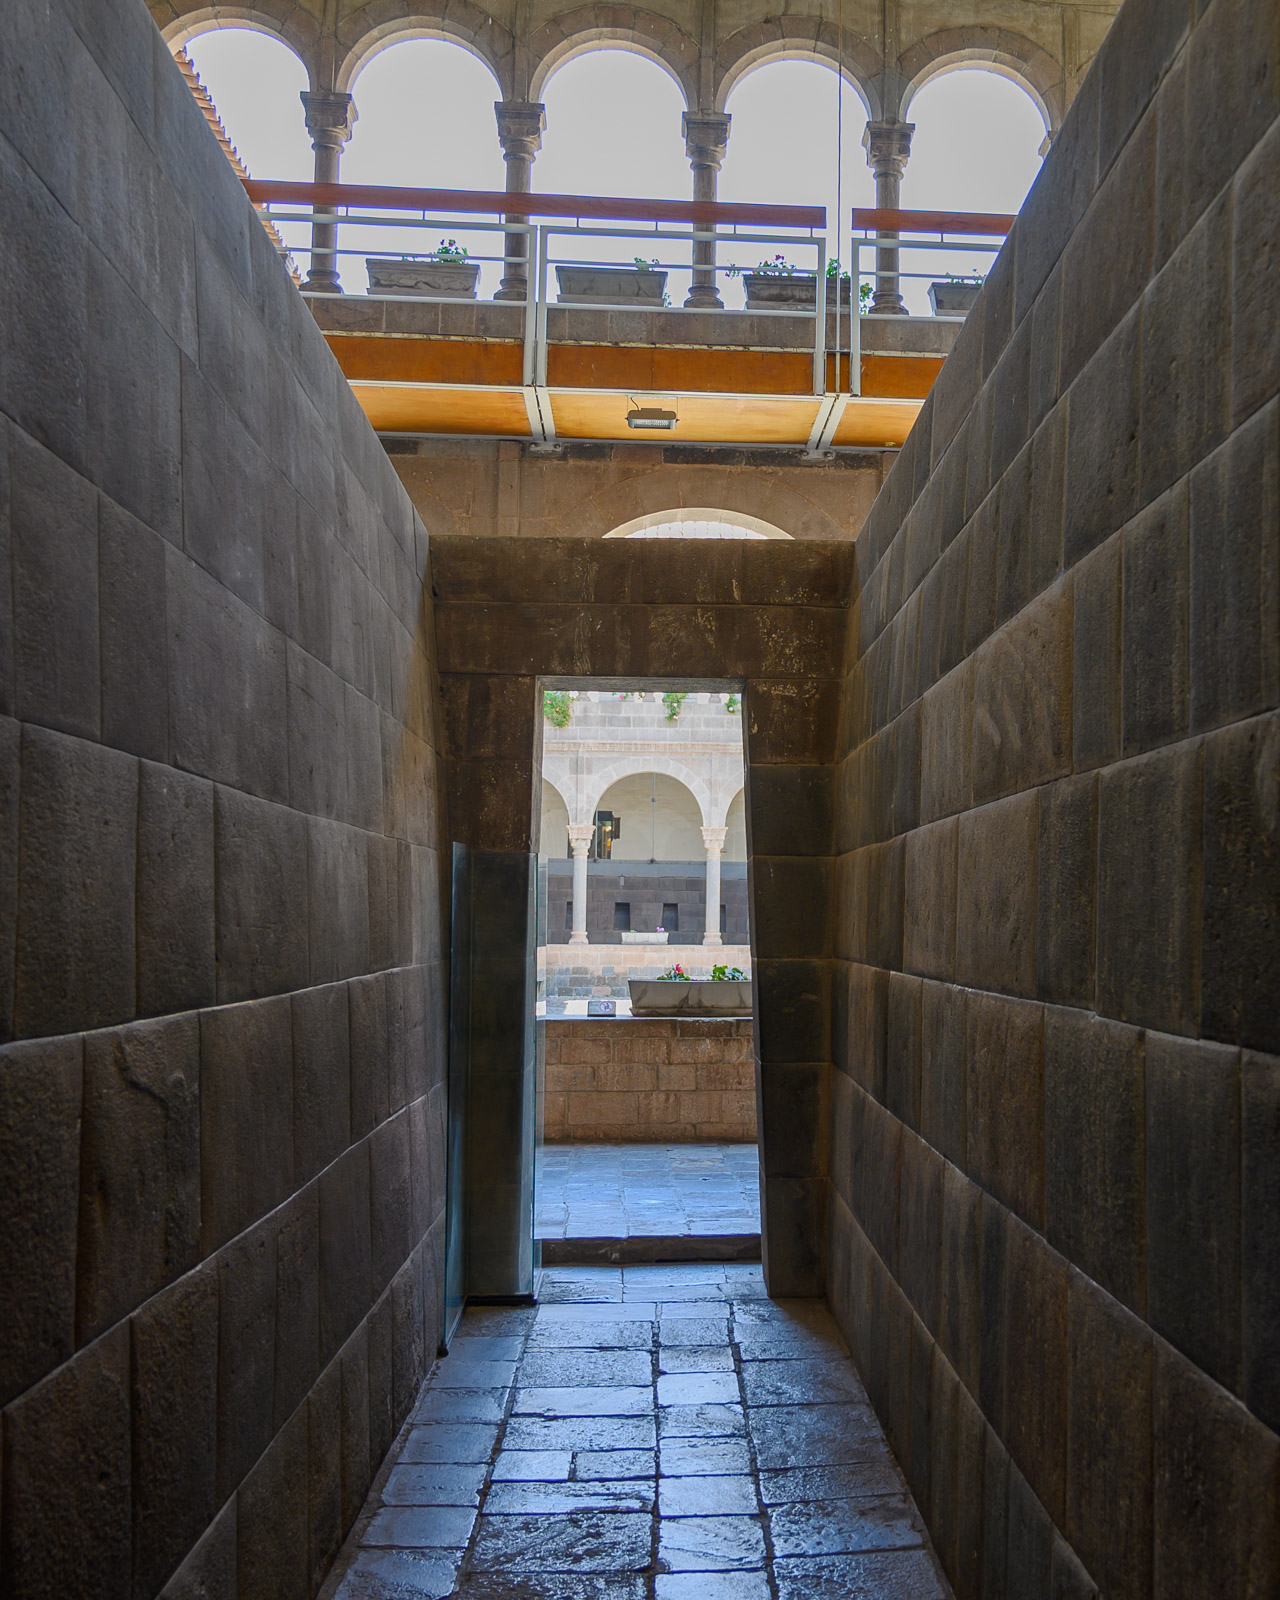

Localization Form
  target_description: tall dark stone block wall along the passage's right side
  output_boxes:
[829,0,1280,1600]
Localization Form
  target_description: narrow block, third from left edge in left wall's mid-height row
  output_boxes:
[138,762,216,1016]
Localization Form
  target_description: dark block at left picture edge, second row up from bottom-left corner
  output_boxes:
[0,1035,83,1405]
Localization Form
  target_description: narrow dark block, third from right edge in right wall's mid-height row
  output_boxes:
[1035,773,1098,1005]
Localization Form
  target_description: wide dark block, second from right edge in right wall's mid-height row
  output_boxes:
[1098,744,1200,1034]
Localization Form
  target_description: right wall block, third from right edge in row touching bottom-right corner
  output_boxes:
[1062,1270,1154,1600]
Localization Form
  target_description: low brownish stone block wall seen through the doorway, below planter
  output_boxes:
[546,1018,755,1144]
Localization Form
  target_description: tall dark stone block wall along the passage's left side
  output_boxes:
[0,0,445,1600]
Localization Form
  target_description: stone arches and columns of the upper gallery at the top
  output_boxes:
[150,0,1100,302]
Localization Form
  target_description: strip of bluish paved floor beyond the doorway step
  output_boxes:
[534,1144,760,1238]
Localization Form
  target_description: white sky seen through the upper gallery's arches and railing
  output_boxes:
[187,29,1045,310]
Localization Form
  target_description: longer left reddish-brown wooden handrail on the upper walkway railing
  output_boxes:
[243,178,827,227]
